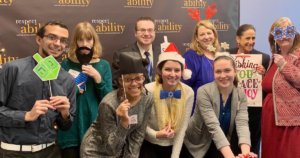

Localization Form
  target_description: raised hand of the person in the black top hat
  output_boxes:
[116,99,130,128]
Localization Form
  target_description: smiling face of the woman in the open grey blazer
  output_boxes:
[214,57,236,90]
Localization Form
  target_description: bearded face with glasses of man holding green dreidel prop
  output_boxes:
[36,25,69,58]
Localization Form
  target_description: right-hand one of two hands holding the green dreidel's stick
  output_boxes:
[50,96,70,120]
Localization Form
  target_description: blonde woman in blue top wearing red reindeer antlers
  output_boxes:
[183,20,220,113]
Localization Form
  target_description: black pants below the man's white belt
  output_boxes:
[0,144,60,158]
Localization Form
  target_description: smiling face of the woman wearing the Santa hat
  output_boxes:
[159,60,182,91]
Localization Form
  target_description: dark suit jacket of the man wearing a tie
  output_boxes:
[112,42,160,89]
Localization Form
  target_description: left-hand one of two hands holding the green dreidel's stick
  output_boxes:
[25,100,55,121]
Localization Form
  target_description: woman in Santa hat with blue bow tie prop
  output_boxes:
[140,43,194,158]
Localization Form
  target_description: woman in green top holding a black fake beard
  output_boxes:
[58,22,112,158]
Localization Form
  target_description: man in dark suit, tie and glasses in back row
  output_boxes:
[112,17,160,88]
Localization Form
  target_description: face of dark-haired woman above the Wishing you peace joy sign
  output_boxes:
[236,29,255,53]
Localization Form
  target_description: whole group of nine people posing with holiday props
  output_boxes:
[0,17,300,158]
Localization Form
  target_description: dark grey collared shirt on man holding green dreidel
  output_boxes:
[0,57,76,145]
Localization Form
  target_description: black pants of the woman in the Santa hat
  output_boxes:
[140,140,173,158]
